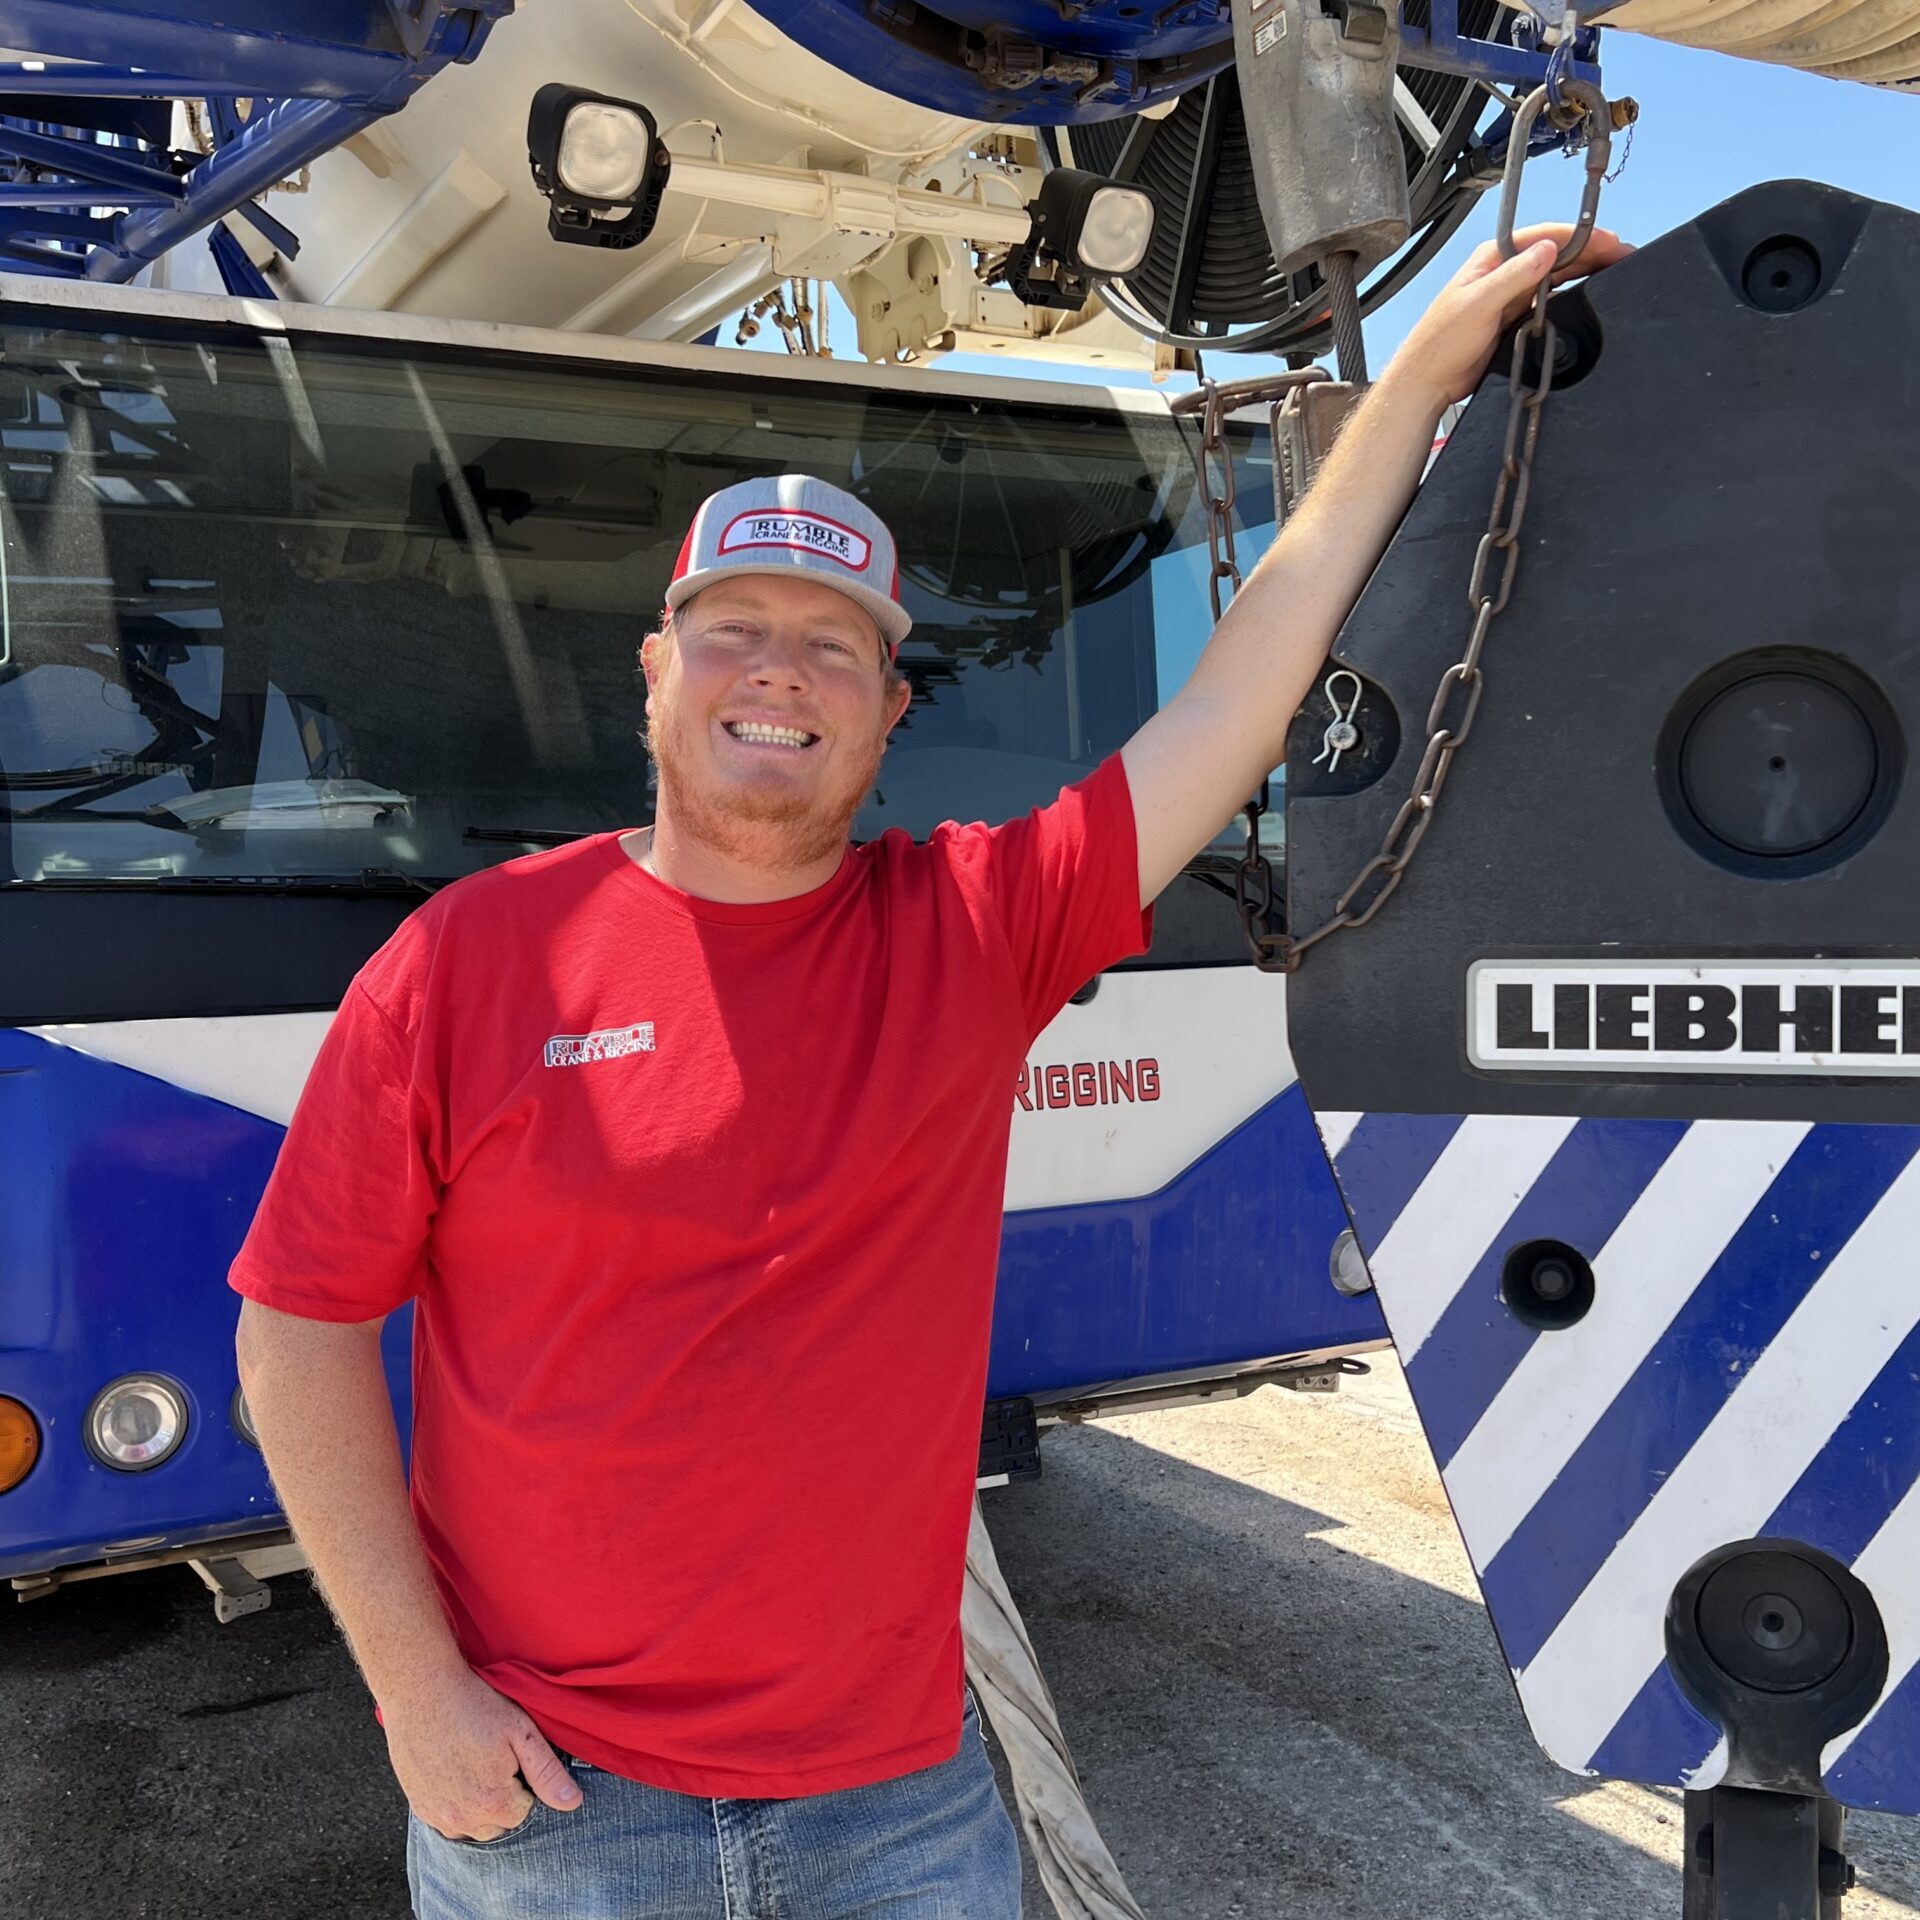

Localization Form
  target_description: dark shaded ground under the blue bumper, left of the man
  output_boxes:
[0,1567,407,1920]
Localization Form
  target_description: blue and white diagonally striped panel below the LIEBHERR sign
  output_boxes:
[1319,1114,1920,1814]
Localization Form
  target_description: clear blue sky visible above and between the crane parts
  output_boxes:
[764,33,1920,386]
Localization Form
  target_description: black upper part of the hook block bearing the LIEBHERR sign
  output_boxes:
[1286,180,1920,1121]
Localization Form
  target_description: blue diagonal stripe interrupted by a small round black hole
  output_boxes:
[1407,1119,1688,1467]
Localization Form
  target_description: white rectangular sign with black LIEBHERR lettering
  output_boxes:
[1467,958,1920,1079]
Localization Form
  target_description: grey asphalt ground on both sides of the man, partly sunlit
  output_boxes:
[0,1367,1920,1920]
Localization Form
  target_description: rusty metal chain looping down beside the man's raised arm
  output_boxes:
[1175,79,1613,973]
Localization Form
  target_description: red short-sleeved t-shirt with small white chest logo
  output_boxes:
[232,756,1150,1797]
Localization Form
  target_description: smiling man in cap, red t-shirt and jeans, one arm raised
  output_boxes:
[232,230,1622,1920]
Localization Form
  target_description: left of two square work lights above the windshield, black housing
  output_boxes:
[526,81,674,248]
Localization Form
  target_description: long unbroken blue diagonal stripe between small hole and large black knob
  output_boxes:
[1480,1127,1920,1667]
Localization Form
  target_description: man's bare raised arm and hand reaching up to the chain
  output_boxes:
[1121,227,1630,906]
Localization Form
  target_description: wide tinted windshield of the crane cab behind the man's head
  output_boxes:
[0,319,1271,885]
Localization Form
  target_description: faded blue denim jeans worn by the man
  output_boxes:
[407,1701,1020,1920]
